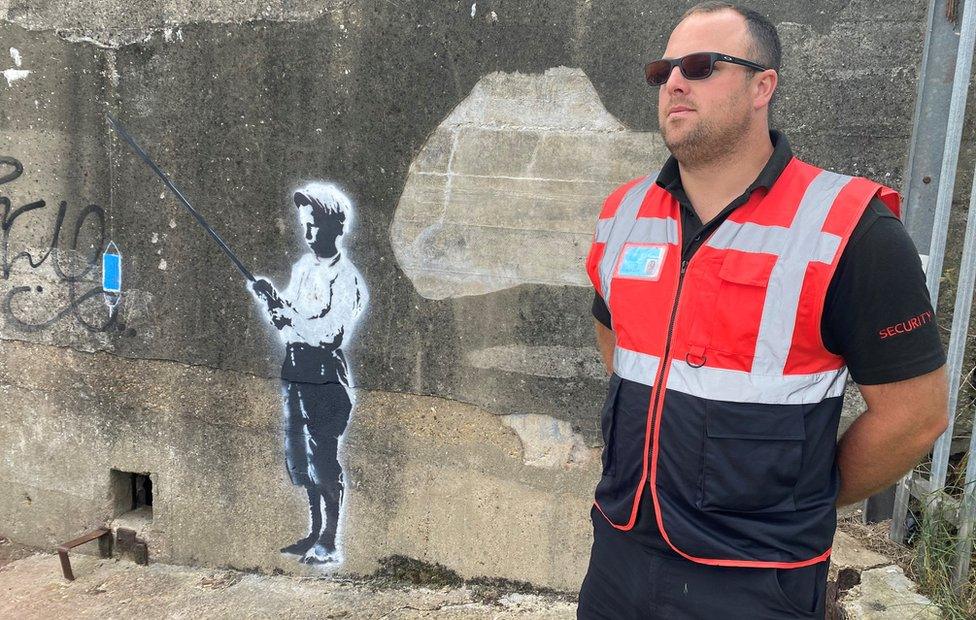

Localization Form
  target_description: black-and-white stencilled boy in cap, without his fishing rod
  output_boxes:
[252,183,367,564]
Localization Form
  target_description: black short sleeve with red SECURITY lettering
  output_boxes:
[821,198,945,385]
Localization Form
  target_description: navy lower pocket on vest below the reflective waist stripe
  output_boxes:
[699,401,805,512]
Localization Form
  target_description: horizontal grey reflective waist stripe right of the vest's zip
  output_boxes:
[664,360,847,405]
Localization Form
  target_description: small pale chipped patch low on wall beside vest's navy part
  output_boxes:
[502,414,591,468]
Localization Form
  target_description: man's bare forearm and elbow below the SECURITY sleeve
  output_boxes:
[837,366,948,506]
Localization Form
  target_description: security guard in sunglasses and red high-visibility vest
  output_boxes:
[579,2,947,619]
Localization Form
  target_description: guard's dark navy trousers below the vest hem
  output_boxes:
[577,515,828,620]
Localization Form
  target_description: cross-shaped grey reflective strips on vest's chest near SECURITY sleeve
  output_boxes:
[708,170,851,375]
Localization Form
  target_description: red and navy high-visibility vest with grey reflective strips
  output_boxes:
[586,158,899,568]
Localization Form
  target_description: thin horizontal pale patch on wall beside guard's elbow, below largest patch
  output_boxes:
[465,345,607,380]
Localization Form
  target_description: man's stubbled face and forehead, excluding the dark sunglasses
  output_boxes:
[658,10,756,165]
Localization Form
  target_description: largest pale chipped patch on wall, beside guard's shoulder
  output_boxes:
[391,67,667,299]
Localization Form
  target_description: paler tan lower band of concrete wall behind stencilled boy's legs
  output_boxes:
[0,341,600,590]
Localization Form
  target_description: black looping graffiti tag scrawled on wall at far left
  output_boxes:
[0,155,117,332]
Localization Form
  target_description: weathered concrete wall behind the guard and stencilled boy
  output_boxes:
[0,0,925,590]
